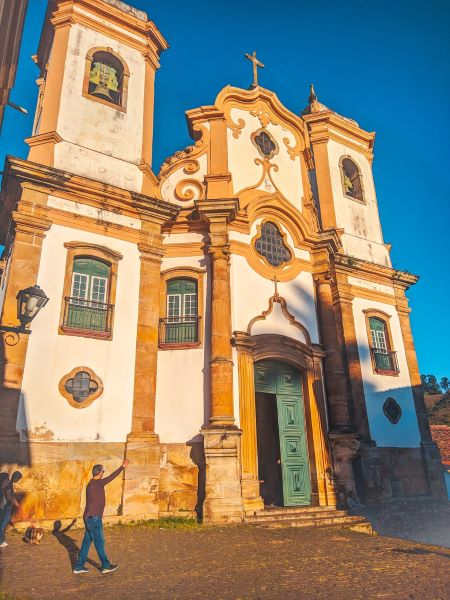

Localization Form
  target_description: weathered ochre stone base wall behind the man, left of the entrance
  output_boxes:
[0,441,204,527]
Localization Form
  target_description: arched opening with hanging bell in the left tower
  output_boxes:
[83,48,129,110]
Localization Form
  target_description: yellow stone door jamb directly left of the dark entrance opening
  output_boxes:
[233,331,264,512]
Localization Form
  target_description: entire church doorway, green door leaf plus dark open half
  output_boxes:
[254,361,311,506]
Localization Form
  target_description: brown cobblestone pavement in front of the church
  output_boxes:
[0,526,450,600]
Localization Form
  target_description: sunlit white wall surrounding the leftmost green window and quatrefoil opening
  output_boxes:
[17,225,140,442]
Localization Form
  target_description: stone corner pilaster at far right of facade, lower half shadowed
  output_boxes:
[394,281,447,500]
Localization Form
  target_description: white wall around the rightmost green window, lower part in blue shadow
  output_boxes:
[353,298,420,448]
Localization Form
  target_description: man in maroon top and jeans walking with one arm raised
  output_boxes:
[73,460,129,574]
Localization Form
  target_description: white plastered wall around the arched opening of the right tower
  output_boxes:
[327,140,391,266]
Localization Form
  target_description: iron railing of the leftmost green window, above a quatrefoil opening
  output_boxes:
[63,298,114,333]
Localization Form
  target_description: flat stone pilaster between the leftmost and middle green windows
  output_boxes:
[122,196,177,519]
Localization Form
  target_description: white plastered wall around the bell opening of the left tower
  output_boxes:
[54,24,148,191]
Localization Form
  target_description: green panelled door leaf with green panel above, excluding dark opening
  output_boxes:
[255,361,311,506]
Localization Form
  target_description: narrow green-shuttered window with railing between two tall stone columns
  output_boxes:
[162,278,198,344]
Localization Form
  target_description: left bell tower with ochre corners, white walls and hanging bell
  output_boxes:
[27,0,168,193]
